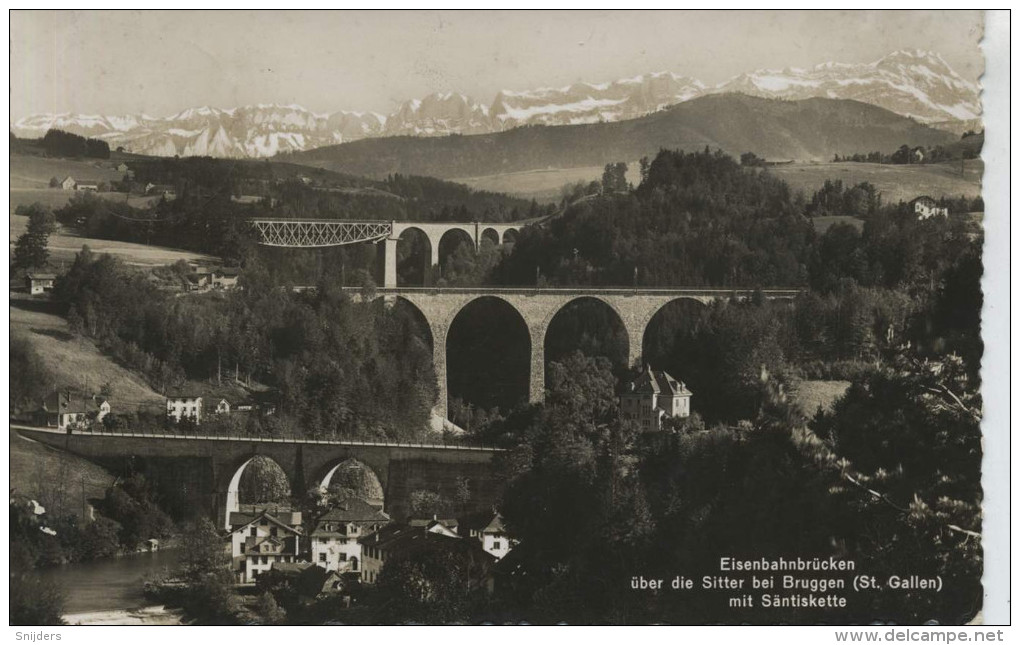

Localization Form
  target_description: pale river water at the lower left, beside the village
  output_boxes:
[39,549,180,614]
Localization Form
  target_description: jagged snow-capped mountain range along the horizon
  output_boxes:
[10,51,981,157]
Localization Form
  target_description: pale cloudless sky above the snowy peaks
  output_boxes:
[3,10,983,122]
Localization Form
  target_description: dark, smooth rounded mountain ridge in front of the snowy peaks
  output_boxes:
[282,94,957,179]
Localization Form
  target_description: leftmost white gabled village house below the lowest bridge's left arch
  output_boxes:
[227,510,302,583]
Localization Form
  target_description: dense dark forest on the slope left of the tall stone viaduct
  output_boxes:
[45,249,436,440]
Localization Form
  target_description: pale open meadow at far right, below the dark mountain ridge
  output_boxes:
[767,159,984,204]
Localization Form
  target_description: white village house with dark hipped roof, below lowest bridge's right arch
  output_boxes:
[308,497,390,577]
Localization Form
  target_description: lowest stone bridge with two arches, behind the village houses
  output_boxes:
[12,426,502,528]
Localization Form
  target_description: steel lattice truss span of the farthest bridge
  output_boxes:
[249,219,393,248]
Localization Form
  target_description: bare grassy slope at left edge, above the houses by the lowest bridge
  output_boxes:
[8,293,164,413]
